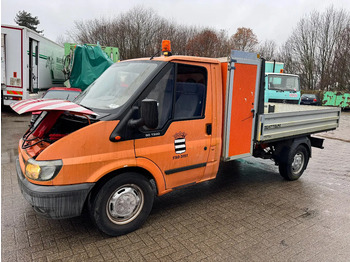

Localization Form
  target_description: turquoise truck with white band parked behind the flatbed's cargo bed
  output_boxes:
[265,61,300,104]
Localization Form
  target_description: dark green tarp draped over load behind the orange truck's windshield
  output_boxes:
[69,45,113,90]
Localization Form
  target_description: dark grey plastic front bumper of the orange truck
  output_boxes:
[16,158,95,219]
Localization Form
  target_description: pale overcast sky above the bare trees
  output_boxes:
[1,0,350,45]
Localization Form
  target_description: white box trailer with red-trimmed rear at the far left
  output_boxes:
[1,25,64,105]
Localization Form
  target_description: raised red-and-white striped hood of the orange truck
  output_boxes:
[11,99,97,115]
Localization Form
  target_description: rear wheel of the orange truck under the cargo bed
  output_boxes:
[279,145,310,181]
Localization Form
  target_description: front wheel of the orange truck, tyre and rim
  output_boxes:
[89,173,154,236]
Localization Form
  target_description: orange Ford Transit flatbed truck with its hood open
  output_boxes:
[12,46,340,236]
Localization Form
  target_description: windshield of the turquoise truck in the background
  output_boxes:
[268,75,300,91]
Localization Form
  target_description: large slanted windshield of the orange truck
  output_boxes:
[74,61,159,110]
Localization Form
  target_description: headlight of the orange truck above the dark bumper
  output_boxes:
[25,158,63,181]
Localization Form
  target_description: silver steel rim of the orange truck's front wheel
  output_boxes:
[106,184,145,225]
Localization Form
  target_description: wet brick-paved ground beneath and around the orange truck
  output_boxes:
[1,109,350,261]
